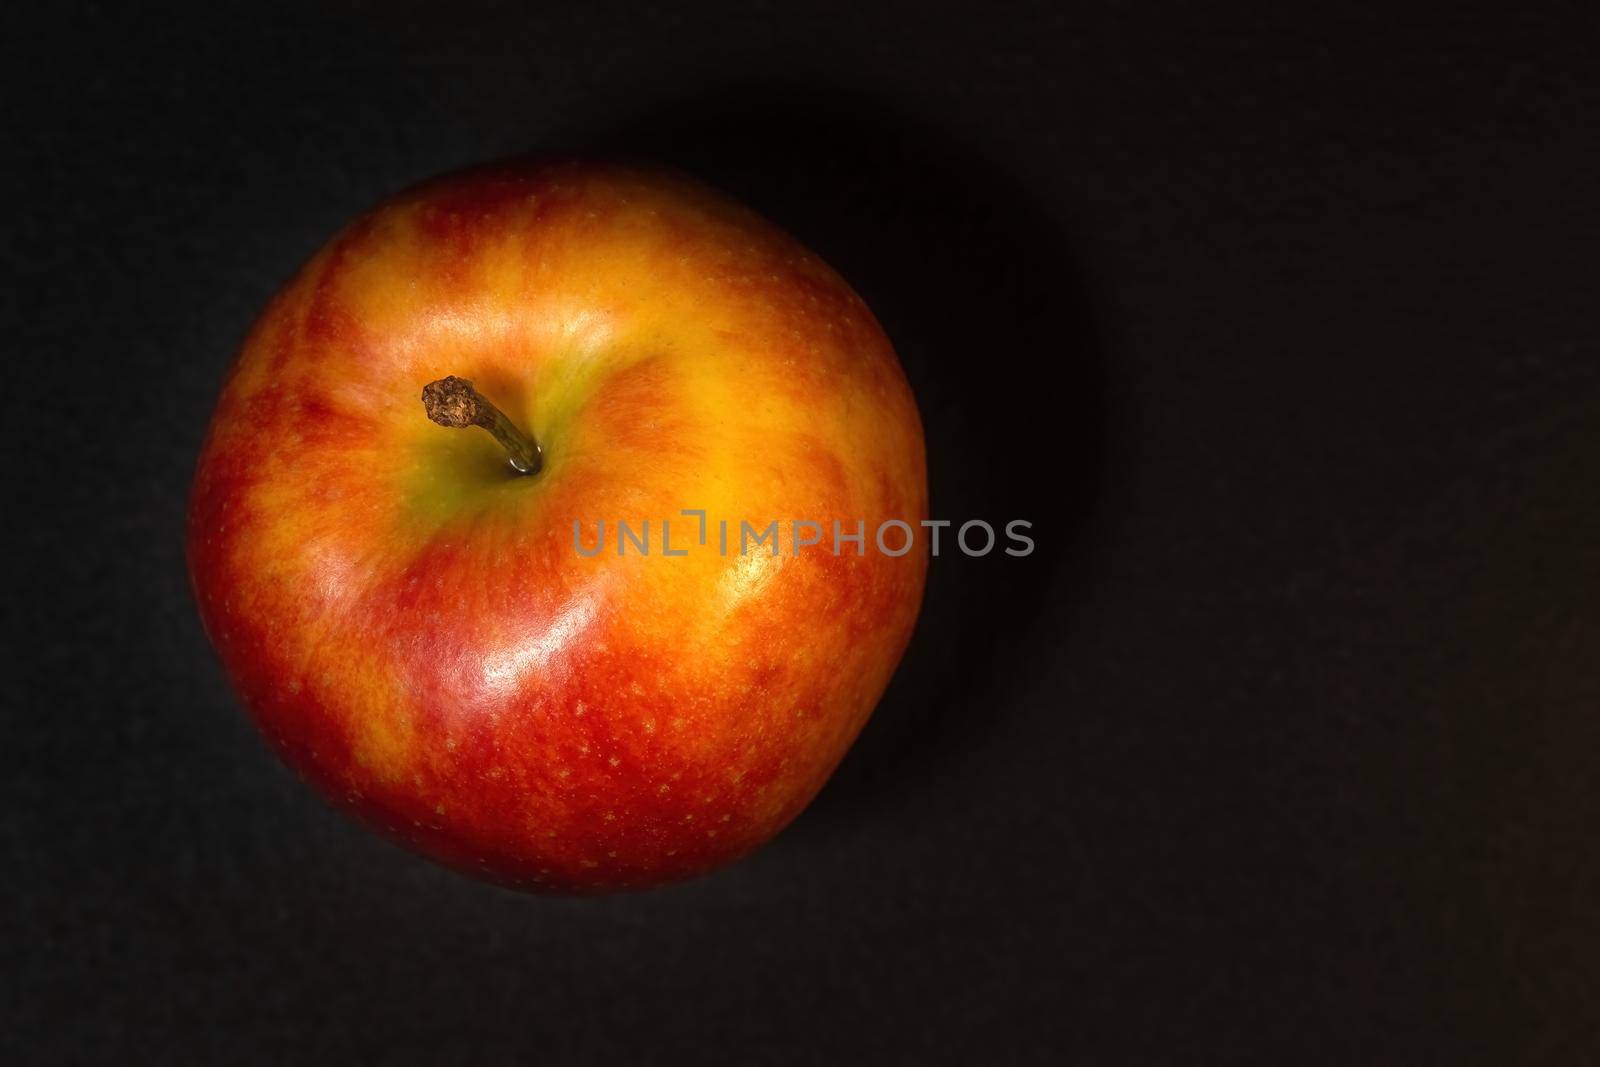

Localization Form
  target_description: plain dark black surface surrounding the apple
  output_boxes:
[9,0,1600,1067]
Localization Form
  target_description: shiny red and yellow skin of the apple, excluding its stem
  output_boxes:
[187,160,926,893]
